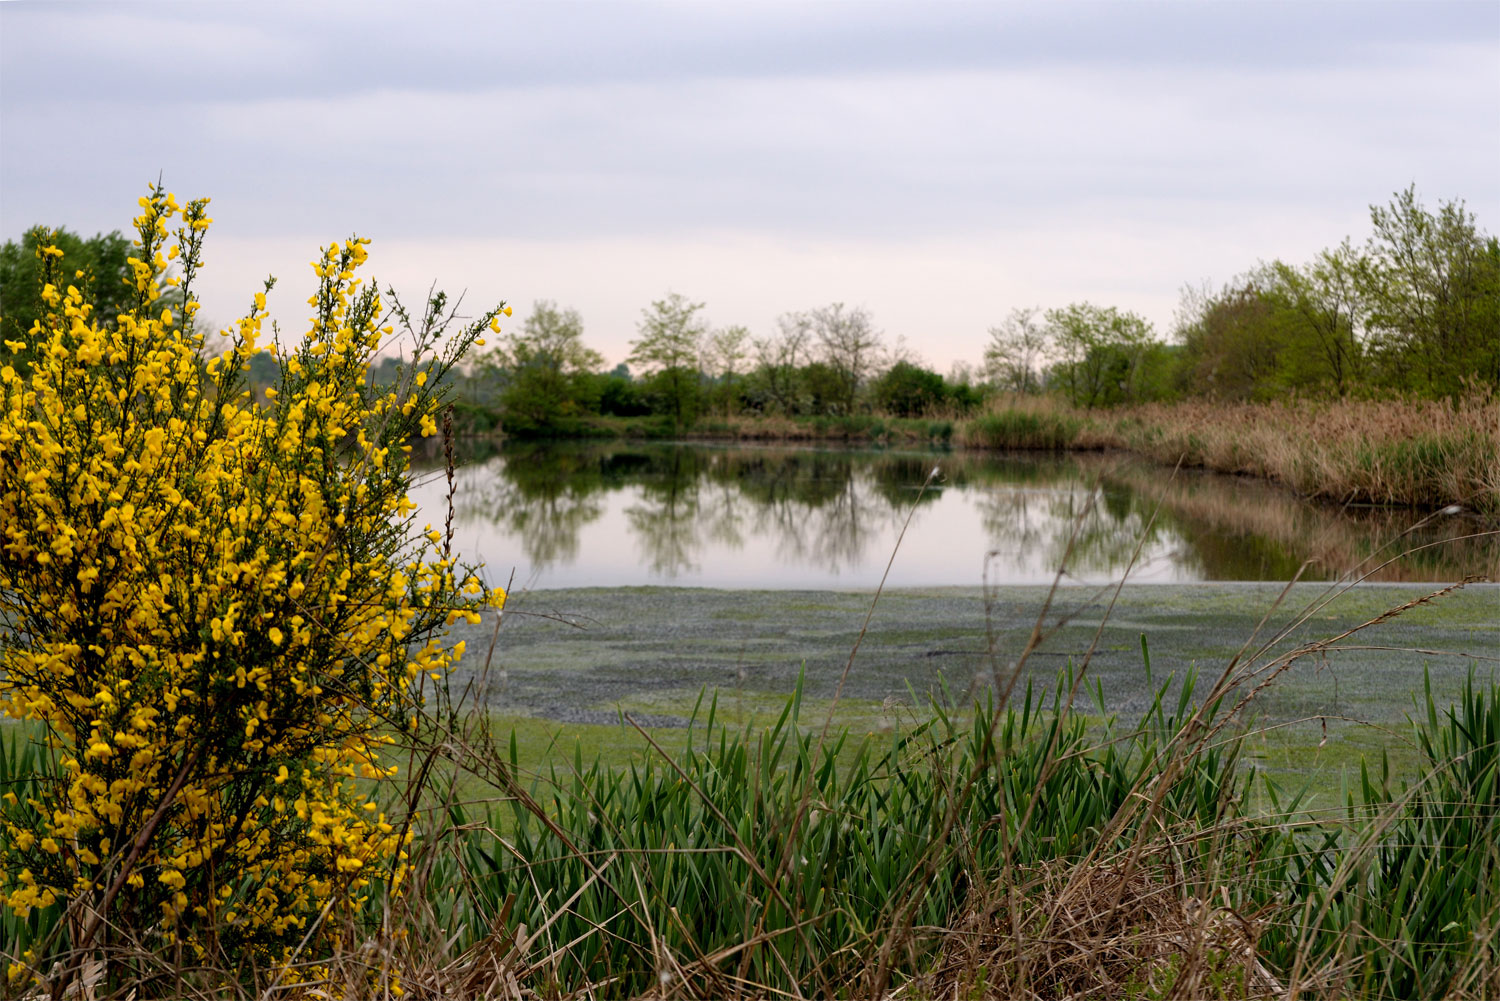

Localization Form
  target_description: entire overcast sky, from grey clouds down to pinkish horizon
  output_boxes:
[0,0,1500,371]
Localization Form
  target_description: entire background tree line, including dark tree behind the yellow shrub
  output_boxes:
[0,188,1500,434]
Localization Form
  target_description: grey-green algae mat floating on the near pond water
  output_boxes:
[447,584,1500,779]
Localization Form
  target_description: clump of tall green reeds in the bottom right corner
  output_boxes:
[1281,675,1500,998]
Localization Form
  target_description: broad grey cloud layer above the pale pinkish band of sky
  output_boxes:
[0,3,1500,255]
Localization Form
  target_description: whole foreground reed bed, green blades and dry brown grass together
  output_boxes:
[289,642,1500,999]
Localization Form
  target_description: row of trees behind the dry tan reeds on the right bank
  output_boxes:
[986,188,1500,407]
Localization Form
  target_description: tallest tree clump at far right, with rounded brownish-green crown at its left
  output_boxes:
[1178,188,1500,399]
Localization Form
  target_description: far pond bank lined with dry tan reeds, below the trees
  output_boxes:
[477,396,1500,519]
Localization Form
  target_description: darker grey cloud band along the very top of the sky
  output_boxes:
[0,0,1500,104]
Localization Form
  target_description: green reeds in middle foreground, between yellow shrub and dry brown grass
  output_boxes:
[408,660,1251,995]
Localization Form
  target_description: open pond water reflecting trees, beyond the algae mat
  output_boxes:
[413,441,1500,590]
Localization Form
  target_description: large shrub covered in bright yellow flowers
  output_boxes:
[0,186,504,962]
